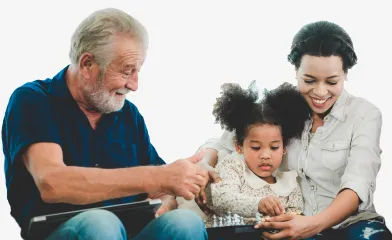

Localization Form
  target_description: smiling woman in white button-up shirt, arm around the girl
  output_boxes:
[197,21,392,239]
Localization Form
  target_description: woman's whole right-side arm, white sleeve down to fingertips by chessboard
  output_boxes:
[259,106,382,239]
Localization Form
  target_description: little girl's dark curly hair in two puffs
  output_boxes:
[213,82,310,146]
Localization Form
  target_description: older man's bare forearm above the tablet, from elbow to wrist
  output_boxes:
[38,166,162,205]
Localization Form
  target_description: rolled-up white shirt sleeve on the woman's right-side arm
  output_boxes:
[340,107,382,210]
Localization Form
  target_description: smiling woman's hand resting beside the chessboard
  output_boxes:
[255,213,320,240]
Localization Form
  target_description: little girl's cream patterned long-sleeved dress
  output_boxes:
[207,152,303,218]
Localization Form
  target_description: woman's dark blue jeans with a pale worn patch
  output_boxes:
[307,219,392,240]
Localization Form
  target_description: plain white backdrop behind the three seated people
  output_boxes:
[0,0,392,239]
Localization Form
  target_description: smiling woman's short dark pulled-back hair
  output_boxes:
[287,21,357,73]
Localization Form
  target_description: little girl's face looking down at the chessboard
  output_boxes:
[236,124,286,183]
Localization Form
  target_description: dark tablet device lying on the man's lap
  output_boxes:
[27,199,162,239]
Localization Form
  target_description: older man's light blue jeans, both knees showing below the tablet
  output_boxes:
[47,209,207,240]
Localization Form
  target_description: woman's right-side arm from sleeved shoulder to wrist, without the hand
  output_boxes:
[314,105,382,230]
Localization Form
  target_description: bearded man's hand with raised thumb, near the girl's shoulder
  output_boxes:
[156,152,209,200]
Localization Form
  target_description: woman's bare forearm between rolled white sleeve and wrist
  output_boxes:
[314,189,359,232]
